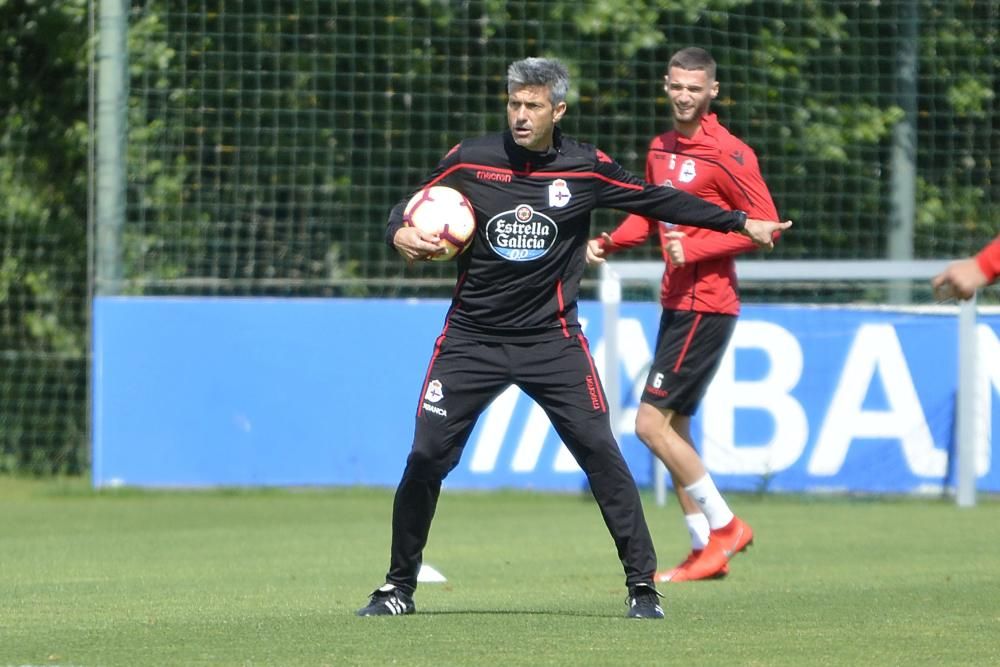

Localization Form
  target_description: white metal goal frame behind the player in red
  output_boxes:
[599,260,979,507]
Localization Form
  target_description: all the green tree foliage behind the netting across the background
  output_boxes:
[0,0,1000,471]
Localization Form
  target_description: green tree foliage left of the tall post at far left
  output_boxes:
[0,0,88,472]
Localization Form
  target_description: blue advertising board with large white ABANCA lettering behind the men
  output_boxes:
[92,297,1000,493]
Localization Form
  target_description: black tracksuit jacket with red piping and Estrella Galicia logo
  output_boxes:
[386,128,746,342]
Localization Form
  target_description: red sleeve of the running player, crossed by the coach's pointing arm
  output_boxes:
[681,148,780,262]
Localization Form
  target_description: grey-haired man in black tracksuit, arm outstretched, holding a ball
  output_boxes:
[358,58,791,618]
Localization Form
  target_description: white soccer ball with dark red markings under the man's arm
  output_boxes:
[403,185,476,262]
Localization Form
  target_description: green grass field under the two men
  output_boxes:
[0,479,1000,667]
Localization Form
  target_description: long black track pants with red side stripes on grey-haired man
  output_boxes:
[386,335,656,592]
